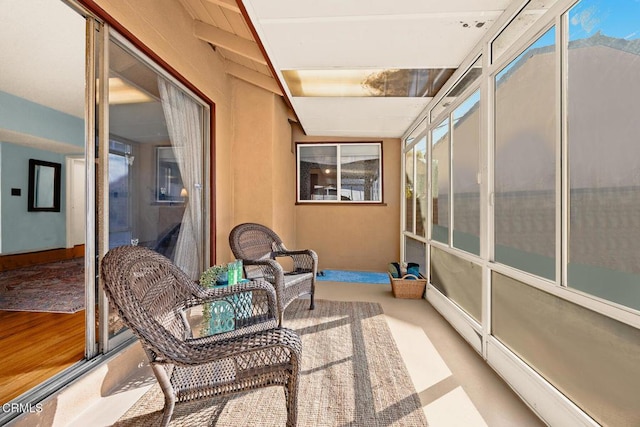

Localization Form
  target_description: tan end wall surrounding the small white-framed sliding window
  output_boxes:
[292,123,401,271]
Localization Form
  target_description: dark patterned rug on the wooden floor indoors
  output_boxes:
[0,258,84,313]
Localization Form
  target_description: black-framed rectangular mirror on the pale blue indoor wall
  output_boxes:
[27,159,62,212]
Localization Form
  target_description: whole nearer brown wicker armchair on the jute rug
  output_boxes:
[101,246,301,426]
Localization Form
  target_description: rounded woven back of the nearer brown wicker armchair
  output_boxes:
[101,246,199,358]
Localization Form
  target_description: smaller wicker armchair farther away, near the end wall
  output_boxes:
[229,223,318,324]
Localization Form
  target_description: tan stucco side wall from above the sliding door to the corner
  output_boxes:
[90,0,295,262]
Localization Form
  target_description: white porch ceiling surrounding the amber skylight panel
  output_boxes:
[241,0,511,137]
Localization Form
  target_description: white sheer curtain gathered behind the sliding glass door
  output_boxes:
[158,77,203,280]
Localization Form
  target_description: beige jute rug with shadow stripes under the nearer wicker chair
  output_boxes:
[115,300,427,427]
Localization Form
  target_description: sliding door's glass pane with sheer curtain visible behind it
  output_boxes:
[100,34,208,348]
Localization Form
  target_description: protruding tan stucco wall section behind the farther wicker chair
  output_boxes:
[224,79,296,260]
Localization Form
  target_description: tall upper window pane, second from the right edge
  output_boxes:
[494,28,556,279]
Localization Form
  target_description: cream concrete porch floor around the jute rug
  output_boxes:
[63,282,544,427]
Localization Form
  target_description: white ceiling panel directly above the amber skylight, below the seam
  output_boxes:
[262,13,499,69]
